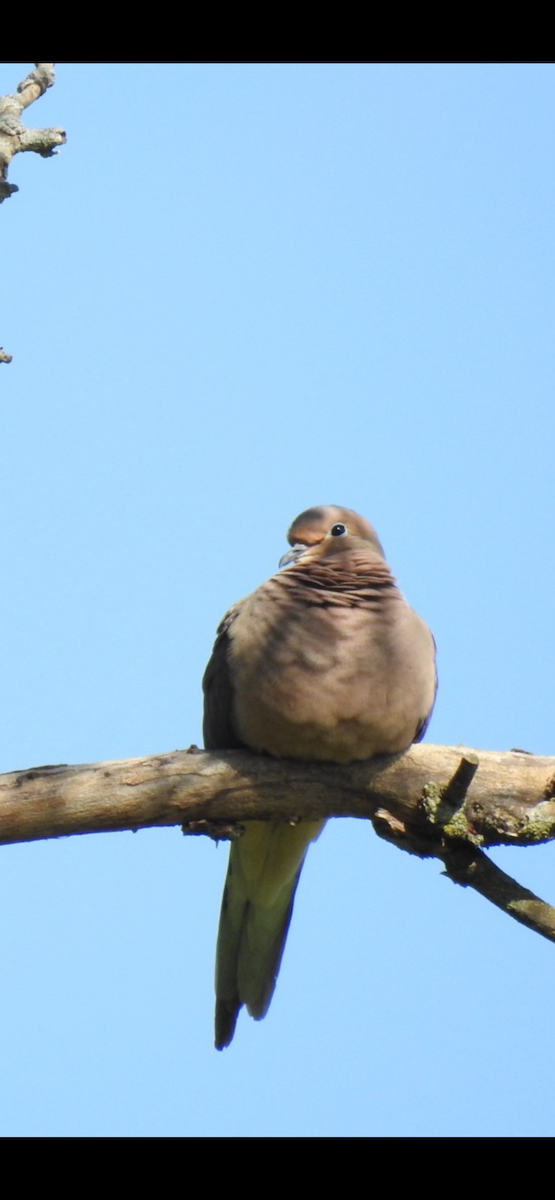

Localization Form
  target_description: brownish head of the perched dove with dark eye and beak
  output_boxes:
[280,504,386,566]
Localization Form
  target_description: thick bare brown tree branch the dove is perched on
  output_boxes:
[0,745,555,941]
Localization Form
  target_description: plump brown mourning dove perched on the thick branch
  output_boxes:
[203,505,436,1050]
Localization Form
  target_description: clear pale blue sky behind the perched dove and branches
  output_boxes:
[0,62,555,1136]
